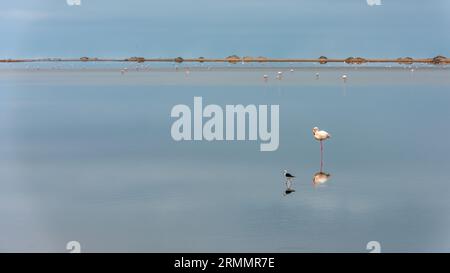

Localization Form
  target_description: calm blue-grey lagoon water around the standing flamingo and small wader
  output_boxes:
[0,68,450,252]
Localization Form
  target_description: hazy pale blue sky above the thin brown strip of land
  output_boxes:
[0,0,450,58]
